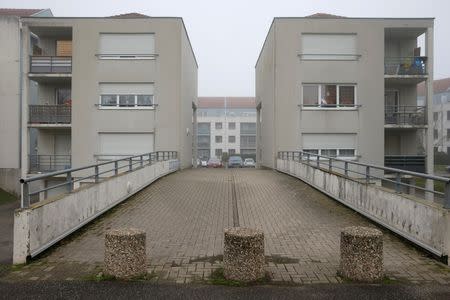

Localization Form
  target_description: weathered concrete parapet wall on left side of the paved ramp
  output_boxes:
[13,160,179,264]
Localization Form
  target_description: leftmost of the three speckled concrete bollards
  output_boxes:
[105,228,147,279]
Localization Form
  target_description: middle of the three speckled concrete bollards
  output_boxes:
[223,227,265,282]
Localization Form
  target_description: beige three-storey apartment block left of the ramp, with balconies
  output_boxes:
[2,9,197,197]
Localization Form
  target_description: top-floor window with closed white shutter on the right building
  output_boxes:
[300,33,358,60]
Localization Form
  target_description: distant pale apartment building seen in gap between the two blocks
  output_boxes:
[197,97,256,159]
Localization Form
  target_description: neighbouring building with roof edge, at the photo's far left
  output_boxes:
[0,8,52,195]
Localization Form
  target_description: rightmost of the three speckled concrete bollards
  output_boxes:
[339,226,383,282]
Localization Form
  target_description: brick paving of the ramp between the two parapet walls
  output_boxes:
[5,169,450,284]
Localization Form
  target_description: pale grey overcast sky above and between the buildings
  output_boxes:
[0,0,450,96]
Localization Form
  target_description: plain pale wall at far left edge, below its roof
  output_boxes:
[0,16,20,195]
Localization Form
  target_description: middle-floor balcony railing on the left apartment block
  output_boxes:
[28,105,72,124]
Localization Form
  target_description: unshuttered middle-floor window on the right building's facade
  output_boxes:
[303,84,356,107]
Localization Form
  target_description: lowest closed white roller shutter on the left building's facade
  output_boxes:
[99,133,154,156]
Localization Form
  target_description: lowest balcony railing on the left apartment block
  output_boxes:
[29,155,72,173]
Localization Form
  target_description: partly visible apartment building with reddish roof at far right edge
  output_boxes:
[418,78,450,153]
